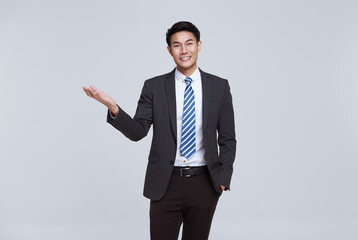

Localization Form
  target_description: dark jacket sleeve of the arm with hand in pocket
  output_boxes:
[217,81,236,190]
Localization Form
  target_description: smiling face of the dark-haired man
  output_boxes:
[168,31,201,77]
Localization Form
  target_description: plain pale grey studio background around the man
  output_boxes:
[0,0,358,240]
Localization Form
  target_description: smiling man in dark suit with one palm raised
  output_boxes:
[83,22,236,240]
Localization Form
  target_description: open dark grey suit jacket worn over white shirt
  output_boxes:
[107,70,236,200]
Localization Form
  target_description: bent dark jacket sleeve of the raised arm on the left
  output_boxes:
[107,81,153,141]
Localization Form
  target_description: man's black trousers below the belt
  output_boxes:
[150,169,221,240]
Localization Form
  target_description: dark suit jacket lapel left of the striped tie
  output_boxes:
[164,69,177,141]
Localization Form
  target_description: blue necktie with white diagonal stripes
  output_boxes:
[180,77,196,159]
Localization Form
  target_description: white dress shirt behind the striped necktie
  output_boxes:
[174,68,206,167]
